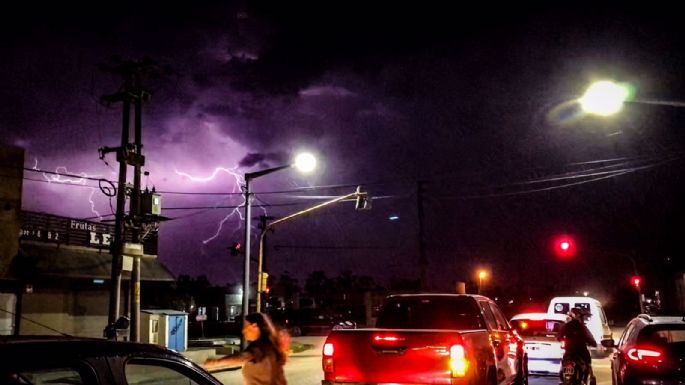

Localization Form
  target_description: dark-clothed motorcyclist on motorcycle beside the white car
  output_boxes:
[557,307,597,384]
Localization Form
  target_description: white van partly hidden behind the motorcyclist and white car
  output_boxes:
[547,297,612,356]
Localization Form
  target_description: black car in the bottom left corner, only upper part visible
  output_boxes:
[0,336,222,385]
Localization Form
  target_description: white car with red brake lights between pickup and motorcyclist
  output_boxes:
[509,313,567,376]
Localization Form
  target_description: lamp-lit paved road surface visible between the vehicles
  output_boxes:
[214,337,611,385]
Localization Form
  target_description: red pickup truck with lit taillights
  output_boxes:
[322,294,528,385]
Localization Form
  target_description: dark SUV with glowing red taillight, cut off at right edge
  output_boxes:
[602,314,685,385]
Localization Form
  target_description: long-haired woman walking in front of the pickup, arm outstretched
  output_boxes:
[202,313,288,385]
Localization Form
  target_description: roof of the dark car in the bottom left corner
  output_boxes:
[0,336,182,362]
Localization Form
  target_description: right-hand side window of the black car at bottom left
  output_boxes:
[126,359,198,385]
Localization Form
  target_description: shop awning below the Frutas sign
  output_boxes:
[11,242,175,281]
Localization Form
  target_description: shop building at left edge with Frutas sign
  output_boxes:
[0,147,174,337]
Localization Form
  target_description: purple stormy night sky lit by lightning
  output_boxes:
[0,1,685,297]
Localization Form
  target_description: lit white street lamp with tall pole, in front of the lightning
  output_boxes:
[242,153,316,347]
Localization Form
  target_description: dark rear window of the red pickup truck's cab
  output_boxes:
[376,297,485,329]
